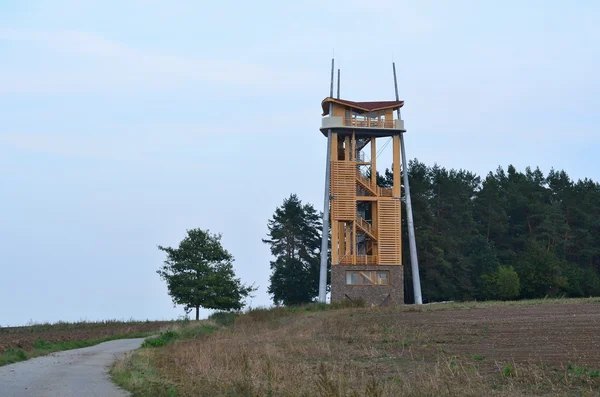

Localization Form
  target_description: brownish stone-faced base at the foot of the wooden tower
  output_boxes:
[331,265,404,306]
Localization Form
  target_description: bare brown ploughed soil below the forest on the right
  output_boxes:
[386,303,600,368]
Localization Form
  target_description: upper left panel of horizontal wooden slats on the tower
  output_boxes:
[331,161,356,221]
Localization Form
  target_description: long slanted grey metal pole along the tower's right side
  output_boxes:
[392,62,423,305]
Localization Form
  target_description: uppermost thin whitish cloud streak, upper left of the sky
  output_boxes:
[0,29,322,94]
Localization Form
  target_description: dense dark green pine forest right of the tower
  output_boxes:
[394,160,600,302]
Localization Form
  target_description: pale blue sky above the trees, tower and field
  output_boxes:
[0,0,600,325]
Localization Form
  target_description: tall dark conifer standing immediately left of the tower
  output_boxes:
[263,194,322,305]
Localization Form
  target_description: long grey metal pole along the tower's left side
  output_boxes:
[319,58,339,303]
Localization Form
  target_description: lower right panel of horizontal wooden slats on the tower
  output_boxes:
[377,200,402,265]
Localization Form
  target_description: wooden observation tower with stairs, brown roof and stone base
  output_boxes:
[321,90,405,305]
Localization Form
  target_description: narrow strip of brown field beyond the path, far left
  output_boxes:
[0,322,170,354]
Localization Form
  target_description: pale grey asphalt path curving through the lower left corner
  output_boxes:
[0,338,144,397]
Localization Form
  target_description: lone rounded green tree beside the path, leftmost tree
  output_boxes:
[157,229,256,320]
